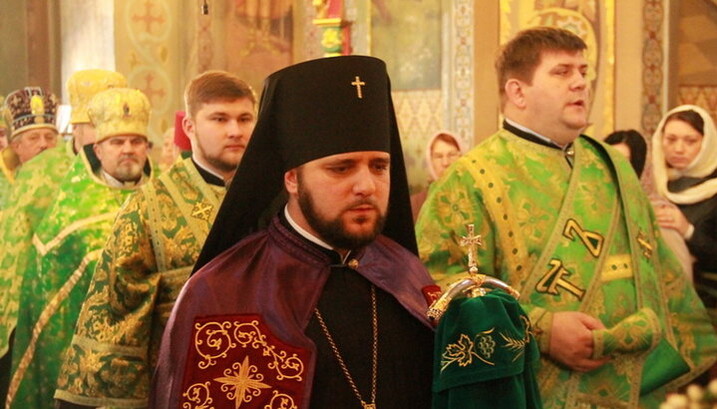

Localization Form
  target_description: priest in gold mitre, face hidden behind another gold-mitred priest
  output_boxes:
[0,69,126,398]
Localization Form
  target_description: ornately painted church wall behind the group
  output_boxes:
[5,0,717,190]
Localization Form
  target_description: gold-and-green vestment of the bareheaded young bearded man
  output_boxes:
[55,158,225,408]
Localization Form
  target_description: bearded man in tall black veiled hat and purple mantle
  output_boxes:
[151,56,438,409]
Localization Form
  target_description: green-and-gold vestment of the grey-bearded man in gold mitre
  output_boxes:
[6,150,150,408]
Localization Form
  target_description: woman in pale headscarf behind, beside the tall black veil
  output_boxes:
[411,131,465,223]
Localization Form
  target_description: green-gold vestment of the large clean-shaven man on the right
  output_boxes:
[416,130,717,409]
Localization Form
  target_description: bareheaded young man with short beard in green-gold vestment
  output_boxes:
[55,71,256,408]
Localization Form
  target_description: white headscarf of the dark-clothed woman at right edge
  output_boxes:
[652,105,717,204]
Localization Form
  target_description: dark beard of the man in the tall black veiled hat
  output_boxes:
[298,183,386,250]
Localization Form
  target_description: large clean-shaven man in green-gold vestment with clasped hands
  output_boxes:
[416,27,717,409]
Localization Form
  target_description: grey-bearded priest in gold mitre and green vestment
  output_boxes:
[5,88,151,408]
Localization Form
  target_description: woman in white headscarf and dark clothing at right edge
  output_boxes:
[652,105,717,308]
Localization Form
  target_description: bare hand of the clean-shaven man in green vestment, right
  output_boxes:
[549,311,610,372]
